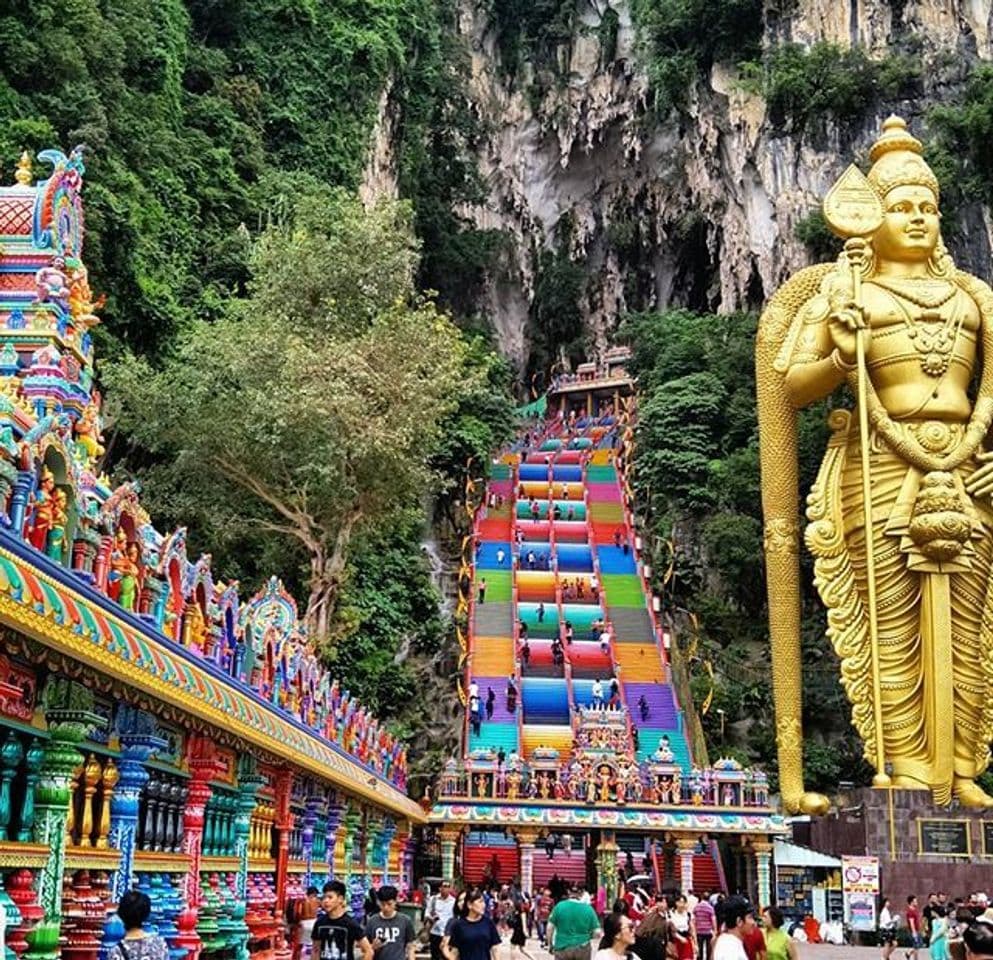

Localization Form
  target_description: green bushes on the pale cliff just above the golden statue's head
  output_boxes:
[762,41,921,132]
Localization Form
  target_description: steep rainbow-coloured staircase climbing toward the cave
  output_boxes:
[466,419,692,771]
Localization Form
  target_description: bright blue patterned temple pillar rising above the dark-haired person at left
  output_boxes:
[109,705,166,903]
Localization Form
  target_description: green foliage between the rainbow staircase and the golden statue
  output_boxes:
[620,310,864,786]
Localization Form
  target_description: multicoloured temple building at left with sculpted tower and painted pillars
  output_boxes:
[0,151,424,960]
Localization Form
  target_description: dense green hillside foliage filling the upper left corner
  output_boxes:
[0,0,430,356]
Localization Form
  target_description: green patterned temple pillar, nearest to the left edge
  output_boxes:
[34,676,102,928]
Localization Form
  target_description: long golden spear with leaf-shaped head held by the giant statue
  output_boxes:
[824,164,890,787]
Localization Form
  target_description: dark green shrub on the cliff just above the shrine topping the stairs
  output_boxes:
[528,250,586,372]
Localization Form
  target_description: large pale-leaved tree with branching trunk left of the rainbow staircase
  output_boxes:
[105,190,473,638]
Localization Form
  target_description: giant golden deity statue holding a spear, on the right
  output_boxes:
[756,117,993,813]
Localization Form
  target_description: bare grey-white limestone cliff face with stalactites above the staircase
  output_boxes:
[384,0,993,369]
